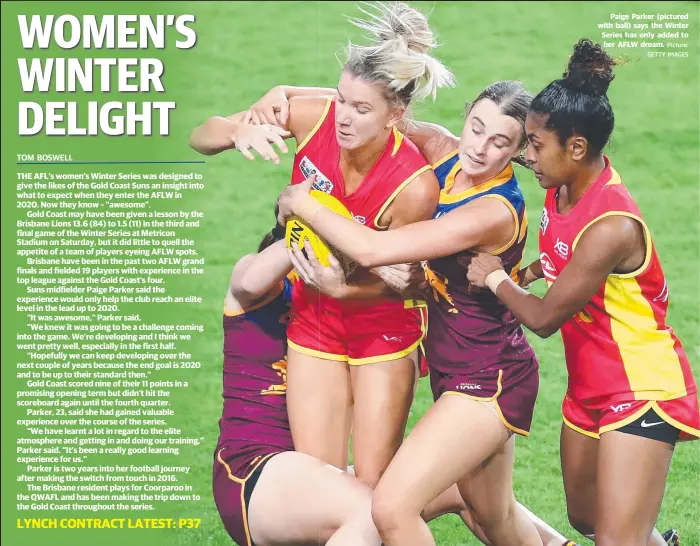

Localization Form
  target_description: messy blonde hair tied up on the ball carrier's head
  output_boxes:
[343,2,455,108]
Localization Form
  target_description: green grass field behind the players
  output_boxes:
[168,2,700,545]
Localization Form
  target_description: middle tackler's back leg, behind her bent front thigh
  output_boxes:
[457,430,544,546]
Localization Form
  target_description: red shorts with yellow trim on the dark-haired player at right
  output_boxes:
[562,392,700,441]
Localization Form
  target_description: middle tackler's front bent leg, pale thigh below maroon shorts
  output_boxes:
[372,396,540,546]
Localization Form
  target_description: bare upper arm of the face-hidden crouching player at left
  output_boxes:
[229,241,292,308]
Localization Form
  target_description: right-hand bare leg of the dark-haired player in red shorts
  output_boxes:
[595,431,675,546]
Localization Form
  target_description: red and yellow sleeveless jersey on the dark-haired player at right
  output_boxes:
[539,157,697,402]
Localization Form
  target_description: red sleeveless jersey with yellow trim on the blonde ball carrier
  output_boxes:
[292,98,431,229]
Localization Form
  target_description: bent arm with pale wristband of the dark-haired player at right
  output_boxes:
[468,216,644,338]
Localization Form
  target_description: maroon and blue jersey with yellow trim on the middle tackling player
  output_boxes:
[425,150,534,374]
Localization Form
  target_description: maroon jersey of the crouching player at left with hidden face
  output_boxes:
[217,279,294,451]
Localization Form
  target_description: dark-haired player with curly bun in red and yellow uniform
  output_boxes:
[468,40,700,546]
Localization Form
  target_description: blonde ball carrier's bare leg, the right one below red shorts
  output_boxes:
[350,351,418,488]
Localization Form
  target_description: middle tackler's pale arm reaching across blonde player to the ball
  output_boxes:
[279,177,515,268]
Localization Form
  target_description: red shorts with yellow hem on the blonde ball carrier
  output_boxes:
[287,283,427,366]
